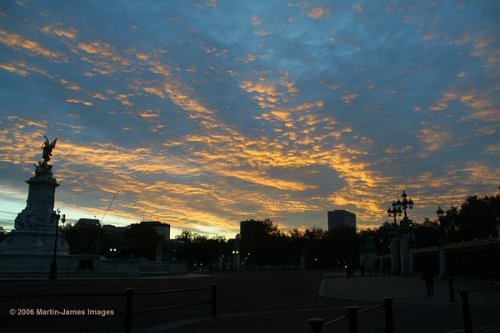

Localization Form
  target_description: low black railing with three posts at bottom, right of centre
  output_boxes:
[309,297,394,333]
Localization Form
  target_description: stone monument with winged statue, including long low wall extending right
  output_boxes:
[0,137,187,279]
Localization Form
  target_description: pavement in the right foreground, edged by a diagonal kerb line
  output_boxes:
[153,273,500,333]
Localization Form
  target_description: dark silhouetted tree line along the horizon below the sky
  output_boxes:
[0,191,494,269]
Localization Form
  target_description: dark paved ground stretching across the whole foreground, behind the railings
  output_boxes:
[0,272,500,333]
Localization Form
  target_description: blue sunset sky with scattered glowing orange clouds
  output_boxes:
[0,0,500,237]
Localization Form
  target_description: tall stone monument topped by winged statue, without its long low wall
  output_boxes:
[0,137,69,271]
